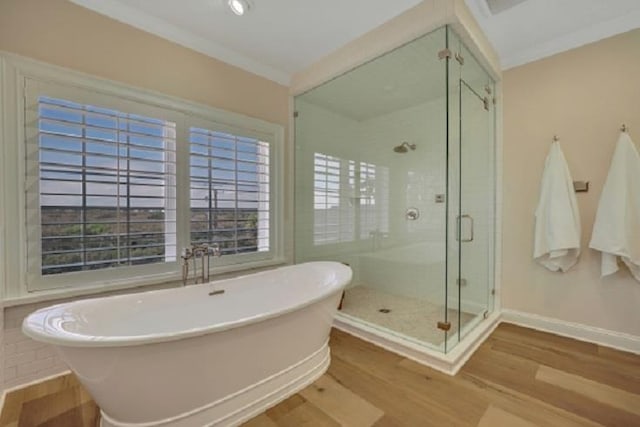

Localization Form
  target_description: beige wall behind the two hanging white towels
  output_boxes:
[503,30,640,336]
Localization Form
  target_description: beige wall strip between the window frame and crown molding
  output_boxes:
[0,0,289,125]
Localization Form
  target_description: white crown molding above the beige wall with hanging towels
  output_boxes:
[500,10,640,70]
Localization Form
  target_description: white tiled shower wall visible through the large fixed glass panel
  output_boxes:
[295,99,446,304]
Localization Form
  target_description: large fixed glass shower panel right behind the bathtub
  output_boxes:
[294,27,447,352]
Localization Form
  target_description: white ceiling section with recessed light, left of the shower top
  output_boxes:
[71,0,420,85]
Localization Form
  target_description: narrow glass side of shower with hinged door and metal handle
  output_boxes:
[446,30,495,352]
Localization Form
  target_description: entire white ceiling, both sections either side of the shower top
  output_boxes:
[71,0,640,85]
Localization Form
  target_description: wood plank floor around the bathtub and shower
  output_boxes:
[0,324,640,427]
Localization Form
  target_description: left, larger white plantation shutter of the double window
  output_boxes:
[25,80,177,289]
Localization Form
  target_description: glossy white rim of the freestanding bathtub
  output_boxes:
[21,261,353,348]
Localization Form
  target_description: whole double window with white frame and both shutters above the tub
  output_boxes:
[5,60,285,298]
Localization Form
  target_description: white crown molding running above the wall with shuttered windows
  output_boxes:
[70,0,291,86]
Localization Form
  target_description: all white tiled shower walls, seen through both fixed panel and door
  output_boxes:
[296,95,494,313]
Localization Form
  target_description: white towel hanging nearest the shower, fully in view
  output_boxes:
[533,142,580,272]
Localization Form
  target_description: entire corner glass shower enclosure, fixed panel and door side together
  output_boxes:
[295,27,495,353]
